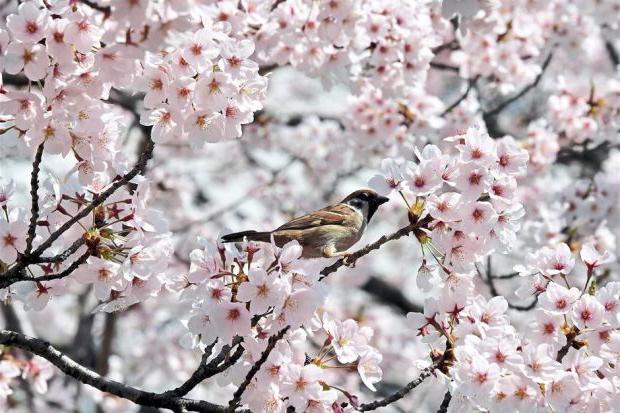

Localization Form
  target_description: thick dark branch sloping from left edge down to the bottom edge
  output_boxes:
[0,330,232,413]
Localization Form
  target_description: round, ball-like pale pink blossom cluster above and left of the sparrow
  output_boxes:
[141,24,267,146]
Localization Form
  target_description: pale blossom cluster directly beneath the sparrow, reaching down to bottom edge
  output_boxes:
[175,241,382,412]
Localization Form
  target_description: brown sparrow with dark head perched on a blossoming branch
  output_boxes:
[221,189,389,258]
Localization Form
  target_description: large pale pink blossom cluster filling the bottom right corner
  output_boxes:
[422,240,620,411]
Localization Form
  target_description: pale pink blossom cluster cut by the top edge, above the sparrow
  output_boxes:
[254,0,440,90]
